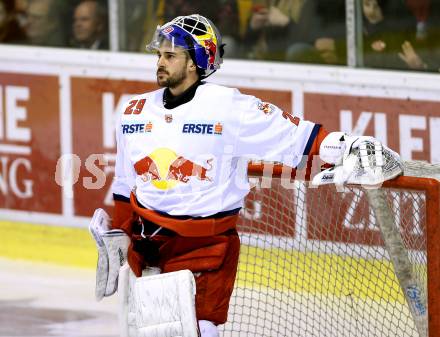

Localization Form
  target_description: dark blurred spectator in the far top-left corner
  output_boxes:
[0,0,24,43]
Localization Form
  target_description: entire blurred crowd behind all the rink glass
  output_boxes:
[0,0,440,72]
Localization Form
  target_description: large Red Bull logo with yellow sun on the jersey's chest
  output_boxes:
[134,148,213,190]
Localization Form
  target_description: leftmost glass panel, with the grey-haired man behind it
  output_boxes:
[0,0,109,50]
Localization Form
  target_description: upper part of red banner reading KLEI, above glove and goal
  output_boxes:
[304,93,440,162]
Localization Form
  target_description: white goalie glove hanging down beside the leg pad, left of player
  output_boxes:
[89,208,130,301]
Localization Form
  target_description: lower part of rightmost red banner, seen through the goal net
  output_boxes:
[306,185,426,250]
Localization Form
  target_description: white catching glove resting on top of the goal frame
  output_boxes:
[312,132,403,185]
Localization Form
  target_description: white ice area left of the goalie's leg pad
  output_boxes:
[0,258,118,337]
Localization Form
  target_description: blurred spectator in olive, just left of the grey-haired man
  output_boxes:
[26,0,67,47]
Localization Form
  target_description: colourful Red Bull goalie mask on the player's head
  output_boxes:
[146,14,223,78]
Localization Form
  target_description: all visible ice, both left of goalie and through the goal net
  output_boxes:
[0,258,417,337]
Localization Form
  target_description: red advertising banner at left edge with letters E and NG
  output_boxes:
[0,73,62,214]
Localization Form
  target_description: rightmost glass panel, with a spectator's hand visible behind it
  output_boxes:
[358,0,440,72]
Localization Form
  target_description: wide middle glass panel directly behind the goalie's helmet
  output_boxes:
[119,0,346,65]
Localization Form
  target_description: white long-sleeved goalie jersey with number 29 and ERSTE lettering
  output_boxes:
[113,83,320,216]
